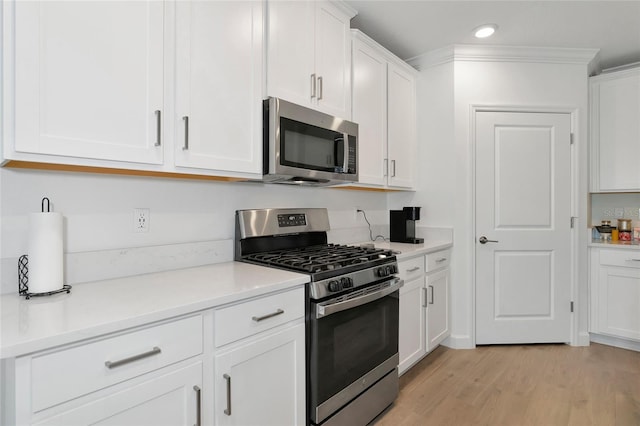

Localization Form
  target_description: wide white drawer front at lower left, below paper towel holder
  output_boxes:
[31,315,202,412]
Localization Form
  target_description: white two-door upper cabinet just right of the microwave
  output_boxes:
[352,30,417,189]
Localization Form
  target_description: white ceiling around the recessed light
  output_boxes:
[346,0,640,69]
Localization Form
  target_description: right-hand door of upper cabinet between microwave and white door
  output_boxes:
[387,63,416,188]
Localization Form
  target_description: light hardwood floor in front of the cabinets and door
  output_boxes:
[373,344,640,426]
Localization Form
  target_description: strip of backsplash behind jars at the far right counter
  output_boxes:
[591,193,640,226]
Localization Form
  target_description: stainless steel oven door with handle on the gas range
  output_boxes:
[309,277,403,424]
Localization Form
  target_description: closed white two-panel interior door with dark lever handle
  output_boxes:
[475,112,571,344]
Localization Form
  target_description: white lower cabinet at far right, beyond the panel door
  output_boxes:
[589,248,640,341]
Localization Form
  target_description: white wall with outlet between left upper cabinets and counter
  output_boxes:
[0,168,388,293]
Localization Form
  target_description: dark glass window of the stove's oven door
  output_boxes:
[309,291,398,405]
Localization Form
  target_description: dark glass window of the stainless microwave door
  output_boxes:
[280,118,344,173]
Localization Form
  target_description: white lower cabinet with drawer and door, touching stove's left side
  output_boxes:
[214,288,306,426]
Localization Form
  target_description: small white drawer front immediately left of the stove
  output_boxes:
[214,288,304,347]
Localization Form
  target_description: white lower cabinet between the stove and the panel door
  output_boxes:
[398,250,451,374]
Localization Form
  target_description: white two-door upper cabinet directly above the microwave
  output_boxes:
[267,1,355,119]
